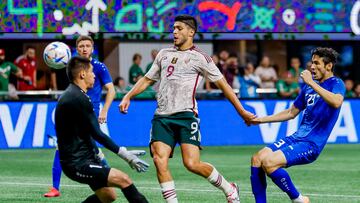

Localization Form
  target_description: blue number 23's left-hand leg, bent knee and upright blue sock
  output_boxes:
[250,147,272,203]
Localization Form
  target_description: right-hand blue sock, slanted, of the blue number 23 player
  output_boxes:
[269,168,300,199]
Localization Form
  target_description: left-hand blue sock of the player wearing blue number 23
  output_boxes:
[250,166,266,203]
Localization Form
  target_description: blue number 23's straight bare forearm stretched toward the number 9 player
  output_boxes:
[250,105,300,125]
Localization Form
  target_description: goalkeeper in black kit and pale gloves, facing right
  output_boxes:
[55,56,149,203]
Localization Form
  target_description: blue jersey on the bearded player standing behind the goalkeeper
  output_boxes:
[87,59,112,117]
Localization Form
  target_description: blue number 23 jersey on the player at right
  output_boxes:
[292,77,345,152]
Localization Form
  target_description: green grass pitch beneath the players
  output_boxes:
[0,145,360,203]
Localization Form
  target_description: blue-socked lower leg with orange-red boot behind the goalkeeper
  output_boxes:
[44,149,62,197]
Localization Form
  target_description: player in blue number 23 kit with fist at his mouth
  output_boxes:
[250,47,345,203]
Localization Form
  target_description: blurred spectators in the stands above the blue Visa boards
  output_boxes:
[0,47,360,100]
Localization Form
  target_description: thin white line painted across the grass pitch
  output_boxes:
[0,182,360,199]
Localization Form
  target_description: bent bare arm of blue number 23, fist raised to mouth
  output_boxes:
[300,70,344,108]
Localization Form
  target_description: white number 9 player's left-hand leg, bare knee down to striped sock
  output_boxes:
[150,141,178,203]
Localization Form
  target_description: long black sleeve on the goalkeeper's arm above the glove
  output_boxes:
[78,95,119,154]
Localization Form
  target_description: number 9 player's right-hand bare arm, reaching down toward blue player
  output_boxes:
[215,77,256,124]
